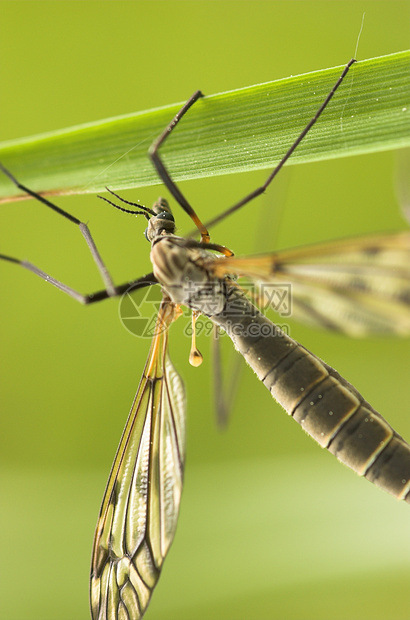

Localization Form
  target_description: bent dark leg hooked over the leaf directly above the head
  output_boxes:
[148,90,209,243]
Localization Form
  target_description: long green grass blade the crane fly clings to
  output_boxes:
[0,51,410,200]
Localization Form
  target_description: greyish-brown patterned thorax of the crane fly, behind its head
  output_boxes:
[151,235,226,316]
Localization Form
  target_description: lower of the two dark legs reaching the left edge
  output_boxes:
[0,254,158,305]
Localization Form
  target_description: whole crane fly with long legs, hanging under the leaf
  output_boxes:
[1,59,410,620]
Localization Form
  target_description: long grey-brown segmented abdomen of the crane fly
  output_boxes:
[211,286,410,503]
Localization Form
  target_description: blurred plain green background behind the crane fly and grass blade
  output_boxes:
[0,0,410,620]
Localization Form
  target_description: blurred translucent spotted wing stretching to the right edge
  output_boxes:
[212,231,410,336]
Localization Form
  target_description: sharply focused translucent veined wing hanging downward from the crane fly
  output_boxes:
[90,302,185,620]
